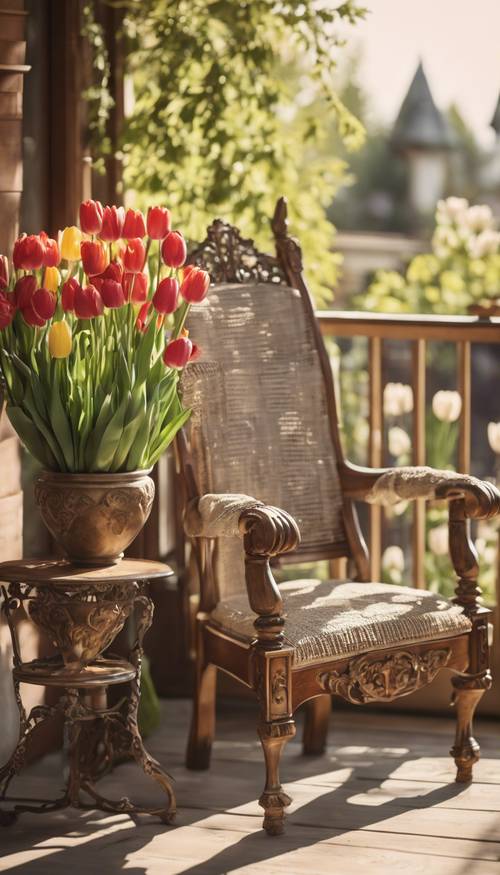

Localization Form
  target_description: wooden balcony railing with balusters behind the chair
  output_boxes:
[317,310,500,588]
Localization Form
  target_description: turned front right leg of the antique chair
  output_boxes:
[450,677,487,784]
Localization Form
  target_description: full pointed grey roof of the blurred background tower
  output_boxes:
[391,62,456,149]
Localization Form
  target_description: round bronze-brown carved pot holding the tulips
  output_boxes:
[35,471,155,565]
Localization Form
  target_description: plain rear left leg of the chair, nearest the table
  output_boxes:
[186,665,217,770]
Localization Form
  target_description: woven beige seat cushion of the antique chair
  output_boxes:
[211,580,471,664]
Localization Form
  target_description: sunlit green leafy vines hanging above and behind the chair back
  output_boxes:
[85,0,364,302]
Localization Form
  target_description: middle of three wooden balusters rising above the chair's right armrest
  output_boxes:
[412,339,426,589]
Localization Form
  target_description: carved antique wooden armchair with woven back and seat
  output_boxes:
[178,199,500,834]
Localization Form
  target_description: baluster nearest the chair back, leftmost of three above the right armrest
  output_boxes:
[369,337,384,580]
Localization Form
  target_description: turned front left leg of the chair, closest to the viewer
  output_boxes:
[258,719,295,835]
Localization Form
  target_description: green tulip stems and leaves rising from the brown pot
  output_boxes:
[0,304,190,472]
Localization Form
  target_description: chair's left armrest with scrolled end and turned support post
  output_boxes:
[184,494,300,648]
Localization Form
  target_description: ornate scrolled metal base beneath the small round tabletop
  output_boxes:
[0,581,176,825]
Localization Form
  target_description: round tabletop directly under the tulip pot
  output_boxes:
[0,559,174,586]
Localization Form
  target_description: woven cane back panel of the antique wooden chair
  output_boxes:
[182,284,345,596]
